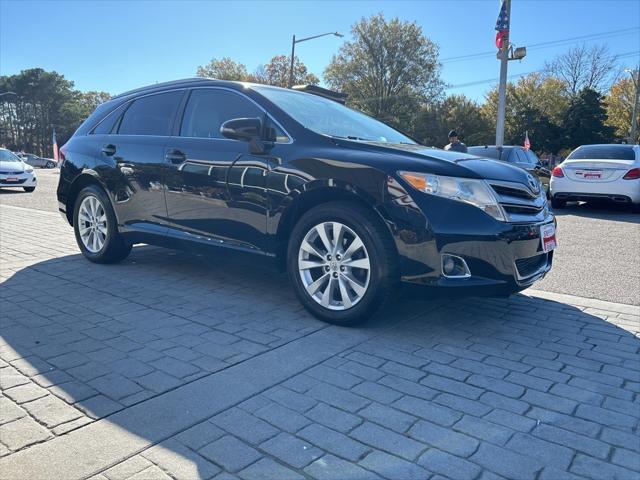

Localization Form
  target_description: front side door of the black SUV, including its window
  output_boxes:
[165,88,271,250]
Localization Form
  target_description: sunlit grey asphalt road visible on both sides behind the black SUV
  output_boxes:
[0,170,640,305]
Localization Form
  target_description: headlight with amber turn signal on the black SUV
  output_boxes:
[398,172,507,222]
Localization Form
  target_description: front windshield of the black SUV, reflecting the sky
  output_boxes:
[253,85,415,144]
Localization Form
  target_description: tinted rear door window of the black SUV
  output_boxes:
[118,91,183,136]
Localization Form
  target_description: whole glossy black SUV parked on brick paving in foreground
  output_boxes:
[58,79,555,325]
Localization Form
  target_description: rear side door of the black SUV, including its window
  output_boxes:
[105,90,185,233]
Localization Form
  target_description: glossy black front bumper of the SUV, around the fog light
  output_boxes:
[388,188,555,296]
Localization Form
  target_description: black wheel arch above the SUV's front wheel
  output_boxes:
[275,184,398,270]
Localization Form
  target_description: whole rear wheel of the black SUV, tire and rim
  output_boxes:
[73,185,131,263]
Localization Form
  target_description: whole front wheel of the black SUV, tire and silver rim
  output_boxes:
[287,202,399,326]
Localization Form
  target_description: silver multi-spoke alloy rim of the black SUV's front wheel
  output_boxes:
[298,222,371,310]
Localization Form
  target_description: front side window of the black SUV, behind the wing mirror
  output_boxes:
[180,89,264,138]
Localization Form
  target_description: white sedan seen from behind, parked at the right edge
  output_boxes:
[551,144,640,208]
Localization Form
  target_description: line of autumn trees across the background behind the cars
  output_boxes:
[0,14,639,156]
